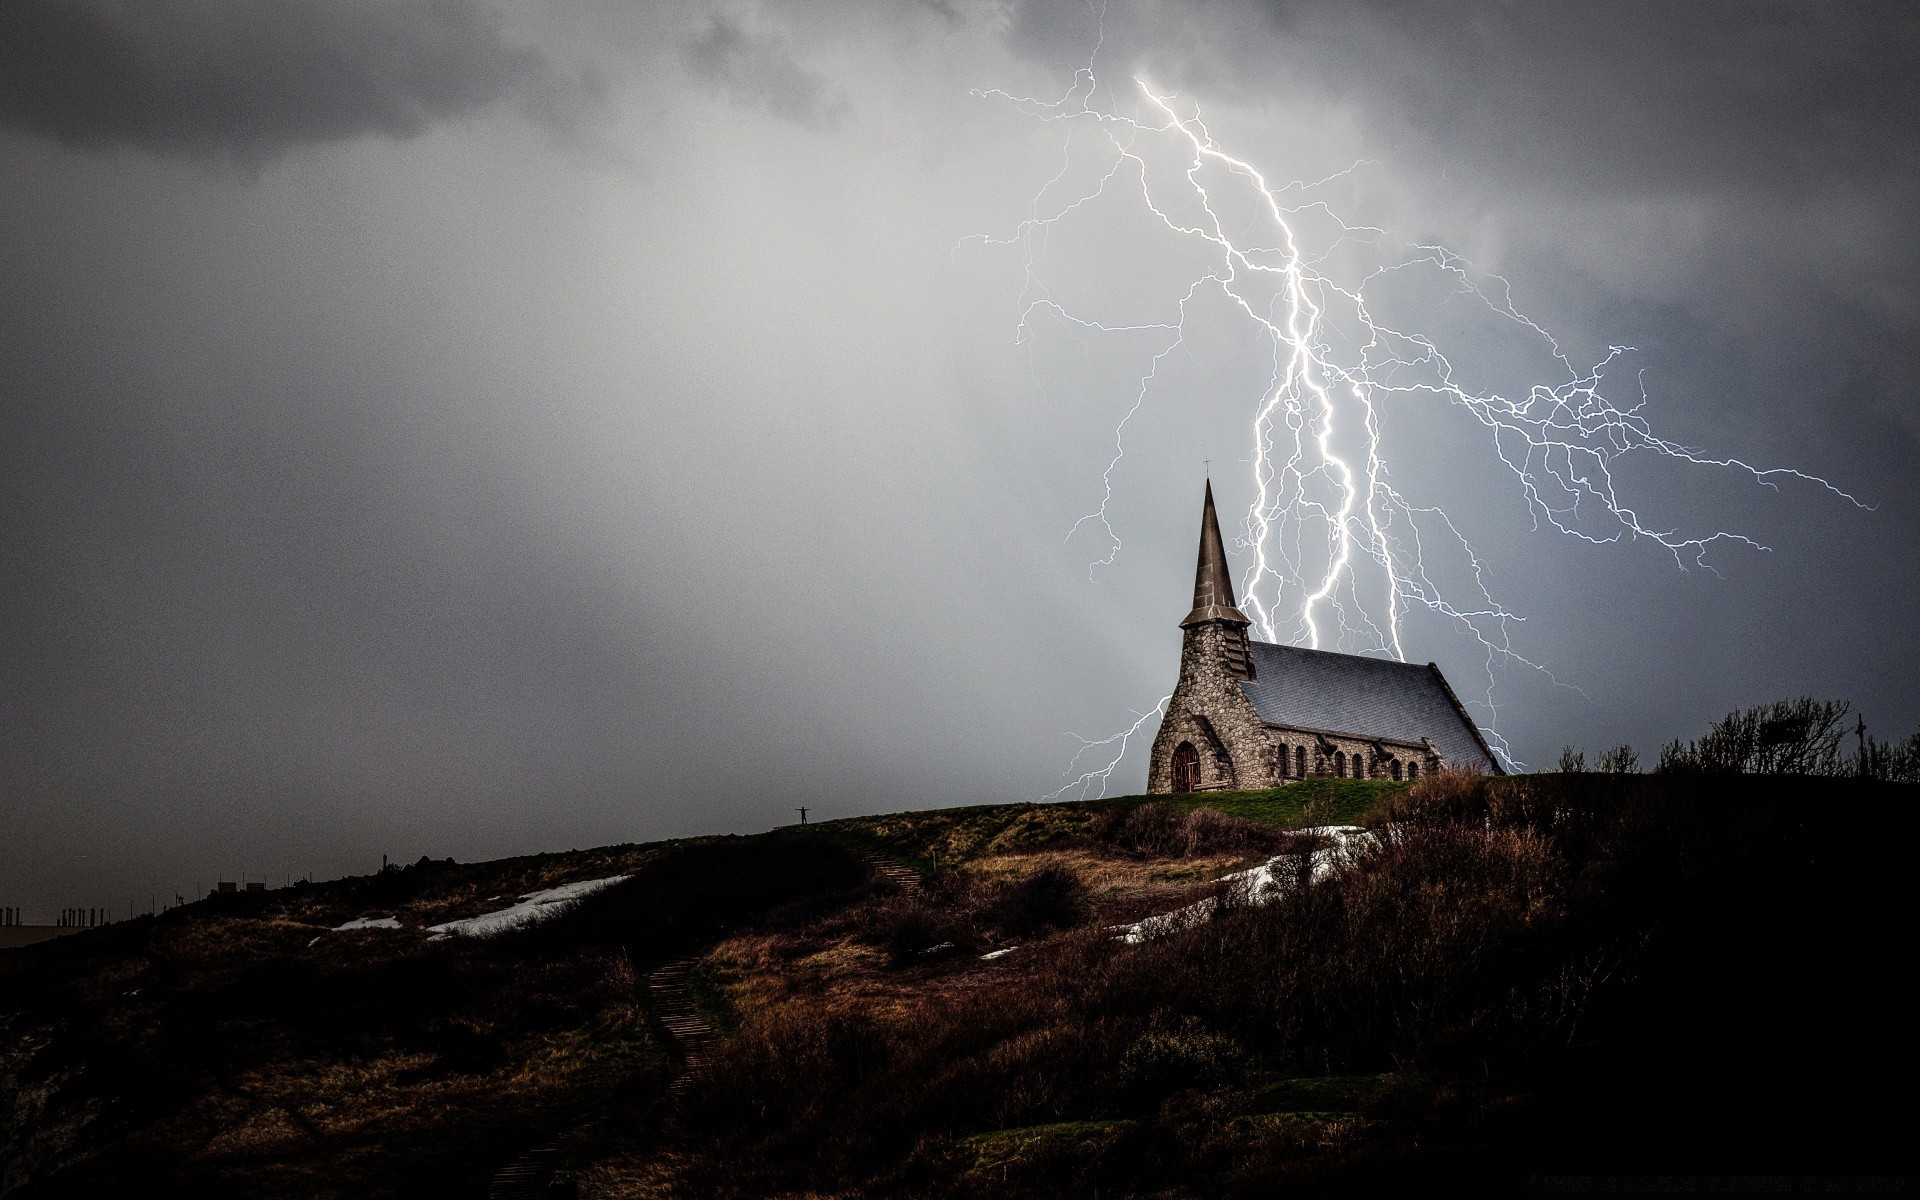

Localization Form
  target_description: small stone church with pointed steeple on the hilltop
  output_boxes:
[1146,484,1501,791]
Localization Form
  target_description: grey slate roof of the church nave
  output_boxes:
[1240,641,1500,772]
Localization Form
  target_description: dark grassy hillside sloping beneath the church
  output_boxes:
[0,774,1920,1200]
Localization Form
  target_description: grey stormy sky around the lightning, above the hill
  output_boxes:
[0,0,1920,920]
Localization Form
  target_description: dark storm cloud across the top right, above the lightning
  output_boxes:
[1010,0,1920,420]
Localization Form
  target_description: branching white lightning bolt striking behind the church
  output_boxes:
[970,21,1870,799]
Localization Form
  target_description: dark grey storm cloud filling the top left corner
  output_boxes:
[0,0,580,161]
